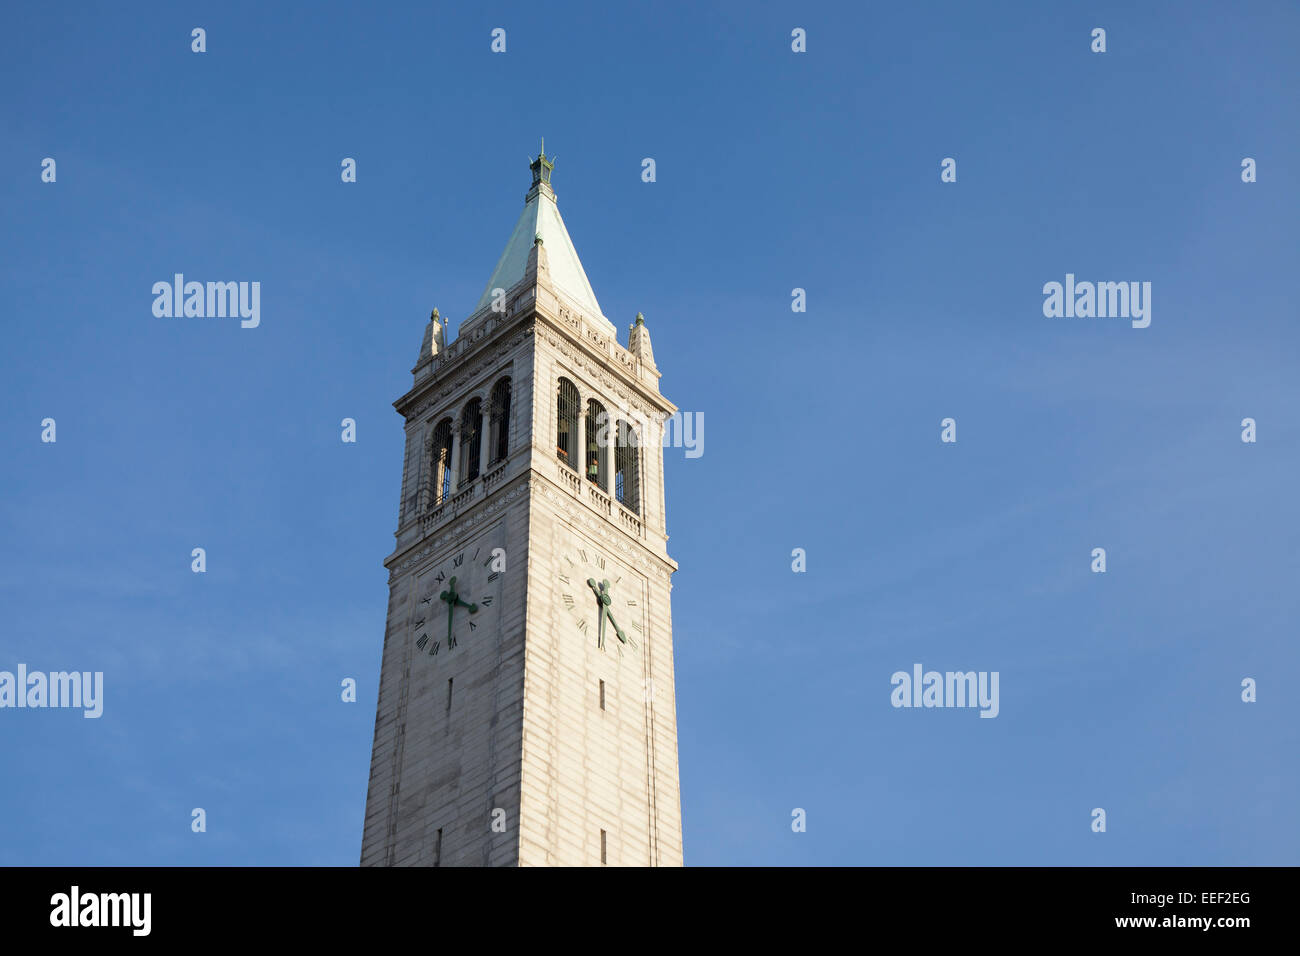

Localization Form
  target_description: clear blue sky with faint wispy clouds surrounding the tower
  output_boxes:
[0,3,1300,865]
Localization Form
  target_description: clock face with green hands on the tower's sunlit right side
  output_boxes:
[555,544,645,657]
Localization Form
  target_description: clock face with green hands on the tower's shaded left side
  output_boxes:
[411,544,502,661]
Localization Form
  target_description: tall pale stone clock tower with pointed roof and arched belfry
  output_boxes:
[361,148,683,866]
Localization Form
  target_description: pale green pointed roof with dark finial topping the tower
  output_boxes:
[473,146,605,320]
